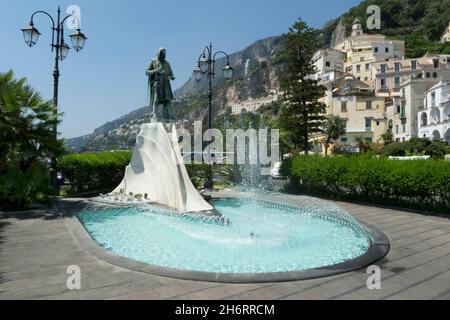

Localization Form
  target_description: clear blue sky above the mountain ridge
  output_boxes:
[0,0,360,138]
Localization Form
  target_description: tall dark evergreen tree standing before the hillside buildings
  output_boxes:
[280,20,326,154]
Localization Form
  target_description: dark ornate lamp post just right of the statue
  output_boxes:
[194,43,233,189]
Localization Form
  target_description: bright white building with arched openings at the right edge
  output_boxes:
[418,81,450,144]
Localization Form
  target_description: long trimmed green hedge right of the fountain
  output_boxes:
[282,156,450,213]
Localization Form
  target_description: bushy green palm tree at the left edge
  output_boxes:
[0,71,64,206]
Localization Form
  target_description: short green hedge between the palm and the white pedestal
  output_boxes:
[58,151,131,194]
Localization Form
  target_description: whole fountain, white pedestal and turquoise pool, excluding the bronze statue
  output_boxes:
[64,48,389,283]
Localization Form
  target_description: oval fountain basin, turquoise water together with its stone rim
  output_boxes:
[63,197,389,283]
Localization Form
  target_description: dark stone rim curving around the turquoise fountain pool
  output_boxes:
[58,196,390,284]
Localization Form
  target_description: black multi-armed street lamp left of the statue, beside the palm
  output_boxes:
[22,7,87,192]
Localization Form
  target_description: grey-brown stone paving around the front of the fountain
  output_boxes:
[0,195,450,300]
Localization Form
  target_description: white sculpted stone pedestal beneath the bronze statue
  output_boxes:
[113,123,214,212]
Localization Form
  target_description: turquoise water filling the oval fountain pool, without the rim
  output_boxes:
[78,199,371,273]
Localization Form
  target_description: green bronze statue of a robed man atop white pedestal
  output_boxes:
[146,48,175,121]
